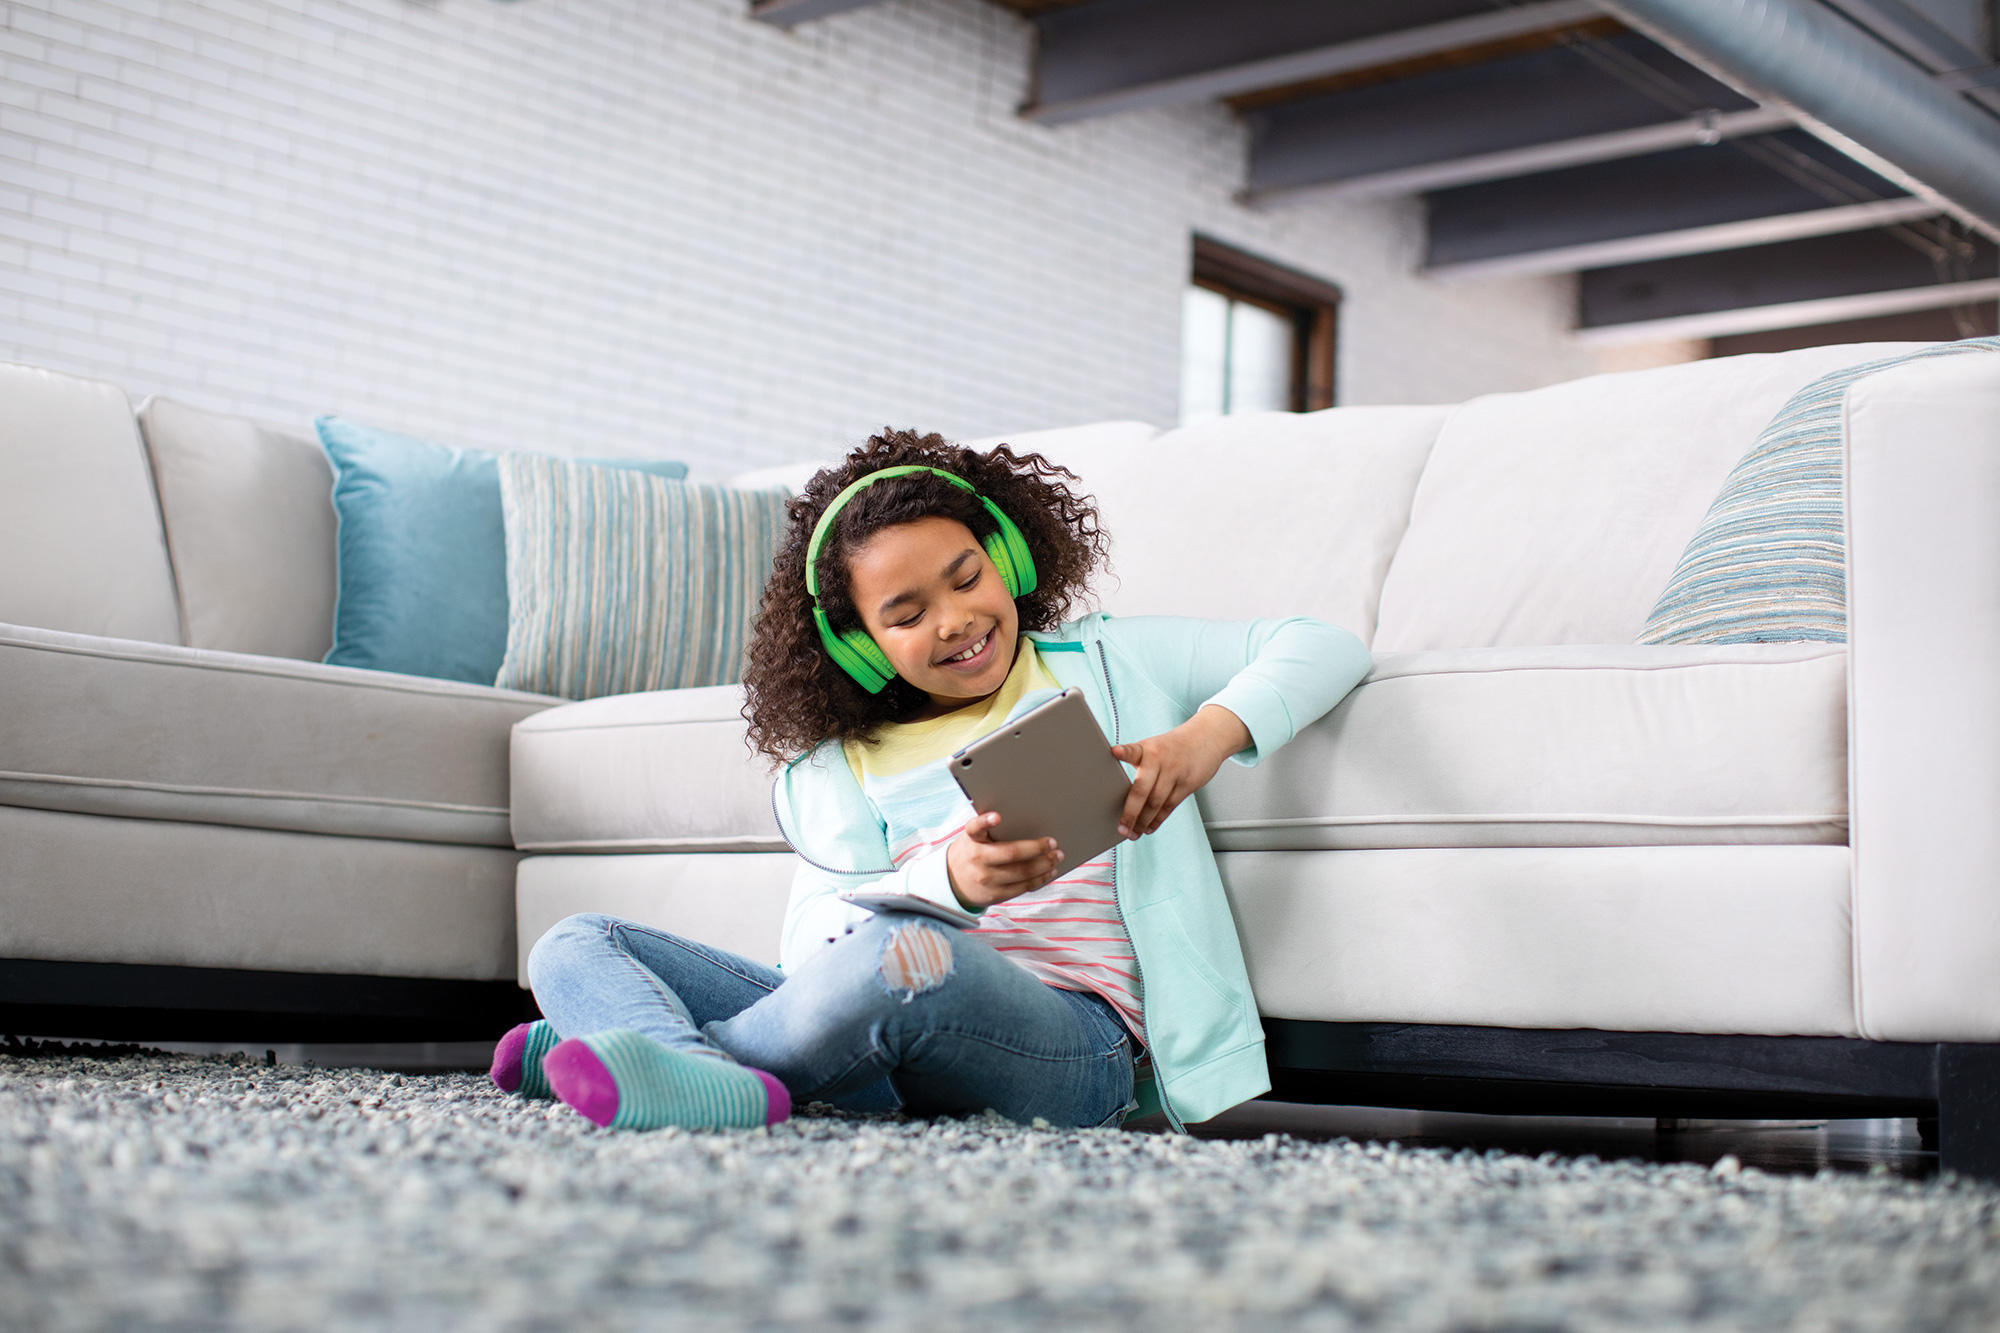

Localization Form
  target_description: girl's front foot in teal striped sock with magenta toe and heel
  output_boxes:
[542,1029,792,1129]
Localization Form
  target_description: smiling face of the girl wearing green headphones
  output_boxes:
[848,518,1020,717]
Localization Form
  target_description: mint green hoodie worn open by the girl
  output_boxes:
[772,614,1370,1129]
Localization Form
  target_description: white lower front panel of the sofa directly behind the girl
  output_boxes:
[504,847,1856,1041]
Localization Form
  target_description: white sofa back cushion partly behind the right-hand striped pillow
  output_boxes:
[1372,342,1918,652]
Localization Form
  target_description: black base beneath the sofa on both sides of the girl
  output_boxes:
[0,959,2000,1179]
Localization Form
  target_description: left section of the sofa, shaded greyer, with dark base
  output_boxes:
[0,366,558,1041]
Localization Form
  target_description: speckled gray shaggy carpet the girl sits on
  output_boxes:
[0,1055,2000,1333]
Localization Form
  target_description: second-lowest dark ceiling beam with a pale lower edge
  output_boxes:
[1424,130,1938,278]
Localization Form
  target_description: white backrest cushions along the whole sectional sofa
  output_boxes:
[19,332,1952,660]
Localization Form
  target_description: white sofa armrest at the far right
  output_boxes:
[1846,350,2000,1041]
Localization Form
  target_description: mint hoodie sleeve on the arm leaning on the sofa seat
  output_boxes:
[1104,616,1372,767]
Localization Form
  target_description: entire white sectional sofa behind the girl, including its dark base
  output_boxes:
[0,344,2000,1173]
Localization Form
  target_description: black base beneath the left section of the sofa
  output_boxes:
[0,959,540,1043]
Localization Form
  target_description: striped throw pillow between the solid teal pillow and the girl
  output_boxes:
[494,454,786,699]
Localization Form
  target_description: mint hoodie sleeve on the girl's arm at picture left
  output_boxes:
[772,743,978,973]
